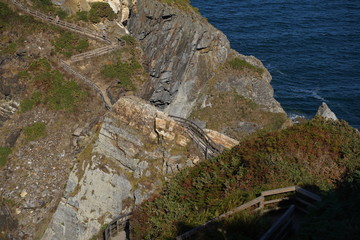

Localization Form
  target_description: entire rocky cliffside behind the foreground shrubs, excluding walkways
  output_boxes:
[0,0,286,239]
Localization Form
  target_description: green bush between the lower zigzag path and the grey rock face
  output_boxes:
[101,60,141,91]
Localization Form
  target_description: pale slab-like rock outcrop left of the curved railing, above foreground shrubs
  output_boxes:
[43,97,201,240]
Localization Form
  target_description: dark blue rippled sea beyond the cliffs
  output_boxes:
[191,0,360,128]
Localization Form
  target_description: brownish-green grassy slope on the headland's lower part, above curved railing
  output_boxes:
[190,90,287,140]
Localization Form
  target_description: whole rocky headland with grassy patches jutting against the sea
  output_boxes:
[127,0,287,139]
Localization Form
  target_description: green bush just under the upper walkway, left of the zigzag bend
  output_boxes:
[53,31,89,57]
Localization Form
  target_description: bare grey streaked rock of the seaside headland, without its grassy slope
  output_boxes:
[128,0,284,117]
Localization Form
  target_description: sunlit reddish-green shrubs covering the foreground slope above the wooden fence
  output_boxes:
[131,118,360,239]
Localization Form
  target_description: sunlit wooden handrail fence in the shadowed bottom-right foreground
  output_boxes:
[176,186,321,240]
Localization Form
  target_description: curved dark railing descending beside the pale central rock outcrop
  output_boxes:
[169,115,224,158]
